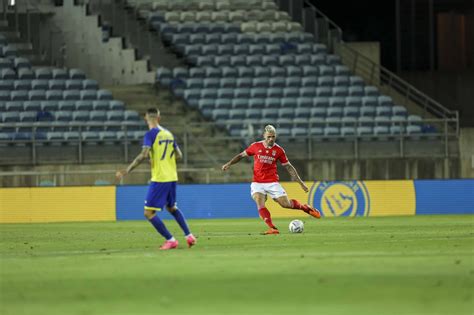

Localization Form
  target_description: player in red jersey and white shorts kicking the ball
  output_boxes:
[222,125,321,234]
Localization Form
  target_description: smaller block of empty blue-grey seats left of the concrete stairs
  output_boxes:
[0,36,144,146]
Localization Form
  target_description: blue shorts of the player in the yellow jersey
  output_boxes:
[145,182,176,211]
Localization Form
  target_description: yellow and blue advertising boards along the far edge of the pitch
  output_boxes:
[0,179,474,223]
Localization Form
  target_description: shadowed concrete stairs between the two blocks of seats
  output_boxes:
[105,84,252,182]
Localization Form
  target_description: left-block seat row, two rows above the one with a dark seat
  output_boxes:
[0,90,112,101]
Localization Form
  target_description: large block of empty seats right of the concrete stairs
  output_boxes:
[142,0,436,138]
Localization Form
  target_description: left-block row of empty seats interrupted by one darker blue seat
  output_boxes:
[0,110,139,123]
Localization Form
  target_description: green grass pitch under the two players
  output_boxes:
[0,216,474,315]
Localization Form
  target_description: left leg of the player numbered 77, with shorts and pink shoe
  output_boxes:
[144,182,178,249]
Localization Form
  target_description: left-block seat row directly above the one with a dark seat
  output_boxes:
[0,100,125,112]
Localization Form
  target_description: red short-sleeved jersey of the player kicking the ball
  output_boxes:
[245,141,289,183]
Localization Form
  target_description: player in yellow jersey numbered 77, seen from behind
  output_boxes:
[116,108,196,250]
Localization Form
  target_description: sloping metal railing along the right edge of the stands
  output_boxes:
[303,0,459,135]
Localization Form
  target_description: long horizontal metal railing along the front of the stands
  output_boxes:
[0,118,457,167]
